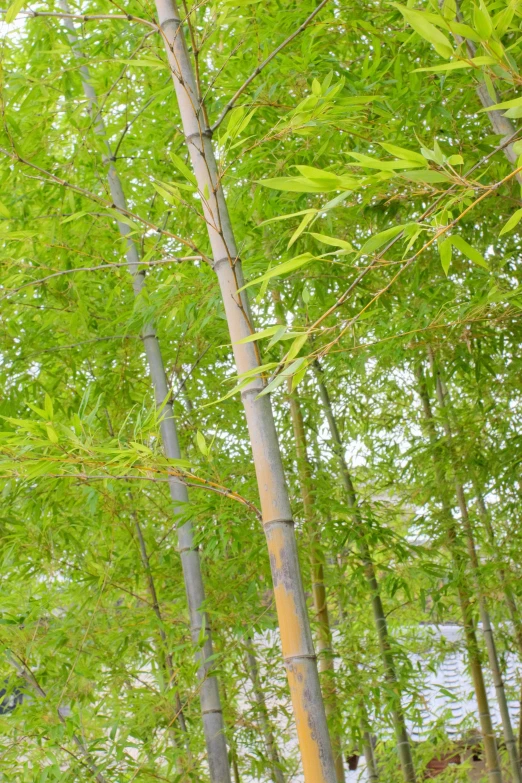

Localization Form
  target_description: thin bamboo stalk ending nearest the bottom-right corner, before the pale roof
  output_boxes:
[430,364,522,783]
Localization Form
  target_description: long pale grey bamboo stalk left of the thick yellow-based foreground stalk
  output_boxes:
[60,7,230,783]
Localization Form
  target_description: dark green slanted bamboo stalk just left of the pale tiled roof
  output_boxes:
[313,361,415,783]
